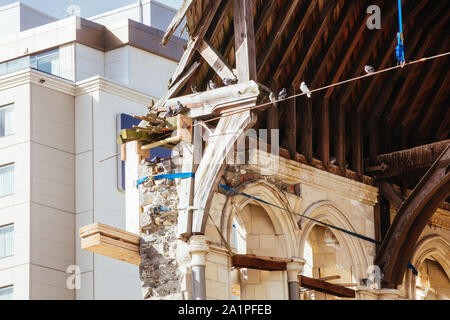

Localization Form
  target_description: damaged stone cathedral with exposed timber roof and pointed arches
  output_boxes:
[80,0,450,300]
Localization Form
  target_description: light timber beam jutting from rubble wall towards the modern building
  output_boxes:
[81,233,141,265]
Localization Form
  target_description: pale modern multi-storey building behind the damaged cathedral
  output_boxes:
[0,1,185,299]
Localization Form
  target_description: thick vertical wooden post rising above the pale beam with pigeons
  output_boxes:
[233,0,257,82]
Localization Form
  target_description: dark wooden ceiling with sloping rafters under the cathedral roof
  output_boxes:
[173,0,450,186]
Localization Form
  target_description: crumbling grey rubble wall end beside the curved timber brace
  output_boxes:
[138,161,190,300]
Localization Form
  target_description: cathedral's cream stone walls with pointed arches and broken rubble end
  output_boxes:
[128,148,448,300]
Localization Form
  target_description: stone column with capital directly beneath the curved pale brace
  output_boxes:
[189,236,208,300]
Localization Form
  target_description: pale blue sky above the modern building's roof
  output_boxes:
[0,0,183,18]
